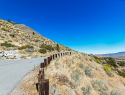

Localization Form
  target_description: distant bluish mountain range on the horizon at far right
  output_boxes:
[96,51,125,57]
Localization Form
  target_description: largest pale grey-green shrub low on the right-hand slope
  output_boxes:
[91,80,108,91]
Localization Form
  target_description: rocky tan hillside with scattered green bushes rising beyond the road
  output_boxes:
[0,19,71,57]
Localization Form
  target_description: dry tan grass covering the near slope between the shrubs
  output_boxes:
[13,54,125,95]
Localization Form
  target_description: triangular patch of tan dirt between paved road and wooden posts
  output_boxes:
[10,68,38,95]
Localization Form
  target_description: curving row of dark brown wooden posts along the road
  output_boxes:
[38,52,71,95]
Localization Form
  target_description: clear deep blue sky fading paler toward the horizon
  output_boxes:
[0,0,125,54]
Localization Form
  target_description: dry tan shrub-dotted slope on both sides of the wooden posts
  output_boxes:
[11,52,125,95]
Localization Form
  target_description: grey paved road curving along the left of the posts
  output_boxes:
[0,57,46,95]
